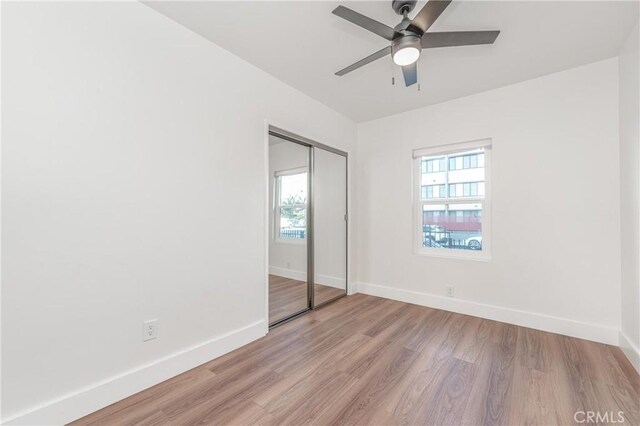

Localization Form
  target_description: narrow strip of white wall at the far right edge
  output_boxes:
[620,21,640,371]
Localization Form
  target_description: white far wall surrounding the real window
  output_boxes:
[357,58,620,344]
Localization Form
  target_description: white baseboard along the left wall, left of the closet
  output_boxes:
[1,320,268,425]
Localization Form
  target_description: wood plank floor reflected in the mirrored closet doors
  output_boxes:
[269,275,344,324]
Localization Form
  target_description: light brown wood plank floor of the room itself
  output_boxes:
[75,295,640,425]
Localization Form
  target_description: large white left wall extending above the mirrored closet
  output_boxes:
[2,2,356,424]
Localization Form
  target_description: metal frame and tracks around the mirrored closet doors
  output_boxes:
[266,125,349,328]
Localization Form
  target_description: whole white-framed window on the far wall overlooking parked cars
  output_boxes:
[414,140,491,259]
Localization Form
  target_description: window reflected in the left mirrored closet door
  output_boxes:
[274,168,308,242]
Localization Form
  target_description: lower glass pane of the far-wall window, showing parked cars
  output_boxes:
[422,203,482,250]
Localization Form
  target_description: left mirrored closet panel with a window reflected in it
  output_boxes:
[269,136,309,324]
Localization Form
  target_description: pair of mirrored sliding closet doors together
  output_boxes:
[268,128,347,326]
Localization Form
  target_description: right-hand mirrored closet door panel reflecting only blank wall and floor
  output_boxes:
[313,148,347,306]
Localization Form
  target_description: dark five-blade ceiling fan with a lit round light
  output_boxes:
[333,0,500,87]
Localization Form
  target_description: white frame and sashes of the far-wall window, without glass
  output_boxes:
[412,139,492,261]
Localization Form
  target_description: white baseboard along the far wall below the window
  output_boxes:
[357,282,619,346]
